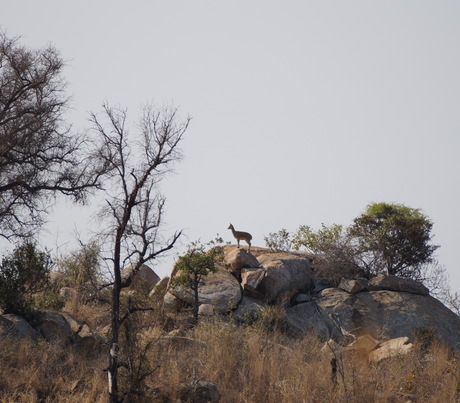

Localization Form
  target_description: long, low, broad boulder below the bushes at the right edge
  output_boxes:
[287,288,460,348]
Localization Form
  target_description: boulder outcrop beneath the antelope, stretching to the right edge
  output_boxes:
[164,246,460,349]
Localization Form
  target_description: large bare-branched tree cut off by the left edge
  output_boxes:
[0,32,104,238]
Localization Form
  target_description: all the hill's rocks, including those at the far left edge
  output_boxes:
[0,246,460,358]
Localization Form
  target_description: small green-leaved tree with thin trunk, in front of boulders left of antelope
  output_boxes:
[171,242,223,323]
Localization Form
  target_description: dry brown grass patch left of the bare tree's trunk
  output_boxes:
[0,339,107,403]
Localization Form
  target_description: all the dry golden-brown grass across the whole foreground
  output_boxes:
[0,305,460,403]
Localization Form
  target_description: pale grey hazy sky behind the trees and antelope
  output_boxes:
[0,0,460,291]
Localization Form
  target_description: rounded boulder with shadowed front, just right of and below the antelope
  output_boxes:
[256,253,312,302]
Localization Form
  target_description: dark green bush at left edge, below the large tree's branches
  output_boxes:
[0,241,51,316]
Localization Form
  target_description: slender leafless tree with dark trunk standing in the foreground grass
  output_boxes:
[91,105,190,402]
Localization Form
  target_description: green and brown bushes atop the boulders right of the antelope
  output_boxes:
[293,203,438,280]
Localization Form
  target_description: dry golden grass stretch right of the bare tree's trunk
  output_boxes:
[149,322,460,403]
